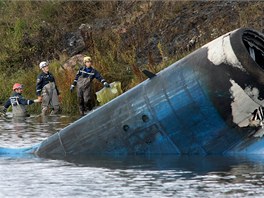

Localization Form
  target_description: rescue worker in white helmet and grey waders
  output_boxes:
[36,61,60,115]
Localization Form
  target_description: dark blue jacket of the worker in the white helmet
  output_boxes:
[36,72,60,96]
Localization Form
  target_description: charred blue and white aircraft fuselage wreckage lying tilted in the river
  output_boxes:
[0,28,264,157]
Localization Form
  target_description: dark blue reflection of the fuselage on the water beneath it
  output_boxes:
[42,155,264,174]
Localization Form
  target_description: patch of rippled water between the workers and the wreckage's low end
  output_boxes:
[0,113,76,147]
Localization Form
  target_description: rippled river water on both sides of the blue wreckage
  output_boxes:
[0,113,264,198]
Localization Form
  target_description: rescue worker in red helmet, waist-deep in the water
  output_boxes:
[2,83,40,117]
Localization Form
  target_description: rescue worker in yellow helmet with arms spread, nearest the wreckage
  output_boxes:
[70,56,110,115]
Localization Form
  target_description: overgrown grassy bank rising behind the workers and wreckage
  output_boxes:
[0,0,264,114]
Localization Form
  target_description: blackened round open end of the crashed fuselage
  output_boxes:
[230,29,264,106]
